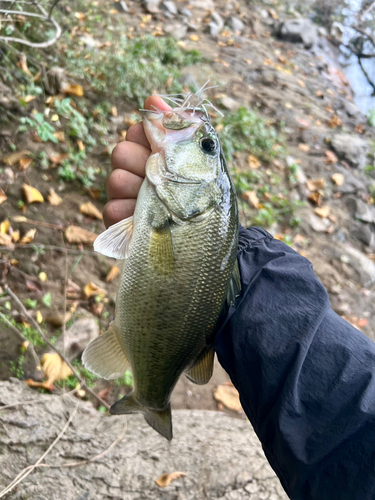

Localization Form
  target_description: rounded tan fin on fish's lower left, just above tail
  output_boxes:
[82,321,129,380]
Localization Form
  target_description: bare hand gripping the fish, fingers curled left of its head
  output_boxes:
[103,96,171,227]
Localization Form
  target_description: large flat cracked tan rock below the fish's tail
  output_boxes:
[0,381,287,500]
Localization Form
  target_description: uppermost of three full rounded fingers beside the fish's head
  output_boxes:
[112,141,151,177]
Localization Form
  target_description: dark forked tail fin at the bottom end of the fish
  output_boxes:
[109,391,173,441]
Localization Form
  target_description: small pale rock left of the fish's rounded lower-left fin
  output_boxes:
[57,316,99,360]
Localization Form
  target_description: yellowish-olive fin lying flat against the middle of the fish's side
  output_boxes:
[149,224,174,276]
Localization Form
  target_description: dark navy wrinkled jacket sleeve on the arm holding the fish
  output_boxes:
[215,228,375,500]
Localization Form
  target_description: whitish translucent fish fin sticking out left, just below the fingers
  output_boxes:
[94,216,133,259]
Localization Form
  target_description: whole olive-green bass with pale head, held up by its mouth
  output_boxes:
[82,94,241,440]
